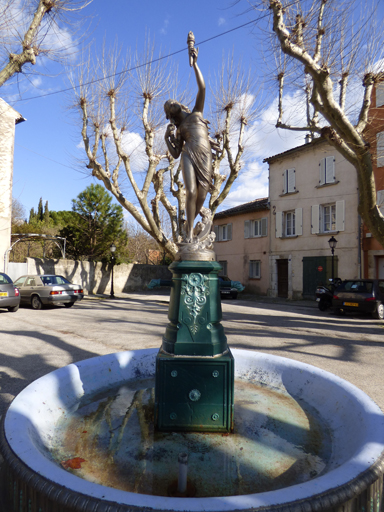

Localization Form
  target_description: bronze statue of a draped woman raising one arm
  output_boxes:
[164,39,213,242]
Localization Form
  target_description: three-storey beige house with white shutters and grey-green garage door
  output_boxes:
[265,138,360,299]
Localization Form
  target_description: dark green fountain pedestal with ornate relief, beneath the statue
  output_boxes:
[155,261,234,432]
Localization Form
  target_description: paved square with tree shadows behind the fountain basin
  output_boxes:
[0,294,384,415]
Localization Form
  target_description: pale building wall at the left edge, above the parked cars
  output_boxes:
[0,98,24,271]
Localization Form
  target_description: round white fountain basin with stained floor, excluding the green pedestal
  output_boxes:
[0,349,384,512]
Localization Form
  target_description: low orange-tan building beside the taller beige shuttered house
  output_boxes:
[213,198,270,295]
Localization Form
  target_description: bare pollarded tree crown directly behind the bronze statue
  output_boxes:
[71,42,258,257]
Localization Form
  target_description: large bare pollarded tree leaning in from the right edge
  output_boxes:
[248,0,384,245]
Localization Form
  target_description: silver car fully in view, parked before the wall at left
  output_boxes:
[15,274,84,309]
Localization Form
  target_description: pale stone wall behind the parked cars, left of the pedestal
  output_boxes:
[27,258,172,294]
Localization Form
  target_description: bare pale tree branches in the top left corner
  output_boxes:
[0,0,92,87]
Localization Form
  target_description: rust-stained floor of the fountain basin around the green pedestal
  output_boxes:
[52,380,332,497]
